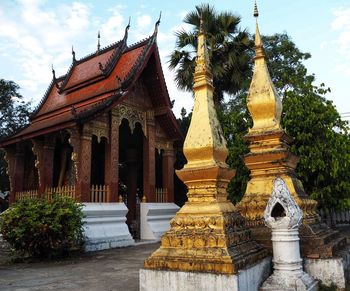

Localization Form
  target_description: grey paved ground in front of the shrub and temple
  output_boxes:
[0,243,159,291]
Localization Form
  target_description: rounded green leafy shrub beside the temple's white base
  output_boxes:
[0,195,84,258]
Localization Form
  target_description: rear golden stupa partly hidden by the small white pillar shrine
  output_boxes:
[237,3,346,257]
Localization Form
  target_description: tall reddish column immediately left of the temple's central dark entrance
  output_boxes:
[105,111,119,202]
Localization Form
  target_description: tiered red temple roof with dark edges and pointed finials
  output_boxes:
[0,22,182,146]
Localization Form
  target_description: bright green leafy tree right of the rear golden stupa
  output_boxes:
[283,84,350,208]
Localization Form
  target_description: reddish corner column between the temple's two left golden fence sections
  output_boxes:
[76,128,92,202]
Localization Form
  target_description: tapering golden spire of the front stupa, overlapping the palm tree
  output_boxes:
[184,16,227,168]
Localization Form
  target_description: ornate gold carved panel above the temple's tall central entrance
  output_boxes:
[118,104,147,133]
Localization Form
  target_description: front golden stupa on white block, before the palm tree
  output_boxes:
[144,20,267,274]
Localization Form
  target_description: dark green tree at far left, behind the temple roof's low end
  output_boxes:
[0,79,30,191]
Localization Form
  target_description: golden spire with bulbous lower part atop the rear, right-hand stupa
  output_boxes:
[248,1,282,133]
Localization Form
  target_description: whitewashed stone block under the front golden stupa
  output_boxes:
[140,258,271,291]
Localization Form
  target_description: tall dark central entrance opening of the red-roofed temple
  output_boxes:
[119,119,144,239]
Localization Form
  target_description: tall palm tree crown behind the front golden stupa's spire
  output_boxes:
[169,4,251,105]
